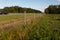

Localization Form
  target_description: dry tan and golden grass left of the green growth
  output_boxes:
[0,14,42,40]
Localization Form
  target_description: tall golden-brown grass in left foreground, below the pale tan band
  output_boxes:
[0,14,41,40]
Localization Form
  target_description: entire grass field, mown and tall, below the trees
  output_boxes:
[0,14,60,40]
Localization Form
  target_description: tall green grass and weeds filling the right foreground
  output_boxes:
[27,14,60,40]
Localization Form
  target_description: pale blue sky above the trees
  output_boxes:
[0,0,60,12]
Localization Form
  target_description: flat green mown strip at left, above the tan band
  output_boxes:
[0,13,38,22]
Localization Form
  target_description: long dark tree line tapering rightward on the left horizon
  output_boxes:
[0,6,41,13]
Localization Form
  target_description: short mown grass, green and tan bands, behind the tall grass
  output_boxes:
[0,13,41,27]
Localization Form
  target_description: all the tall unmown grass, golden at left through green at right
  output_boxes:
[0,14,60,40]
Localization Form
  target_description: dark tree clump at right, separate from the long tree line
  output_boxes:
[45,5,60,14]
